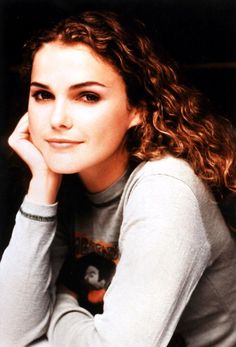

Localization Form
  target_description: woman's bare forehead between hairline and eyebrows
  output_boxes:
[31,42,125,94]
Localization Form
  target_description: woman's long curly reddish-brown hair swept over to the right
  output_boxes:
[21,11,236,191]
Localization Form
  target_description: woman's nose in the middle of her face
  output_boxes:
[51,101,72,129]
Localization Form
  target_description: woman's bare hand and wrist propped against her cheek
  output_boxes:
[8,113,61,204]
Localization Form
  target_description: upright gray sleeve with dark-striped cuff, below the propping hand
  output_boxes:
[0,199,66,347]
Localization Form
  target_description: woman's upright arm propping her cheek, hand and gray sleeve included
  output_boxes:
[0,114,66,347]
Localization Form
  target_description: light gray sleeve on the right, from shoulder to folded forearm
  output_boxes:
[48,175,210,347]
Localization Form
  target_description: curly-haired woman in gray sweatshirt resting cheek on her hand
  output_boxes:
[0,12,236,347]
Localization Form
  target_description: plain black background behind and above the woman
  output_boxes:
[0,0,236,255]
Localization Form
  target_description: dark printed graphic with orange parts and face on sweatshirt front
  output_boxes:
[60,233,118,315]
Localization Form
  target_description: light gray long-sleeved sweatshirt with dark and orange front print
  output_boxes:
[0,156,236,347]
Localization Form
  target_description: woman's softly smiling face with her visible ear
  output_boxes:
[28,42,139,192]
